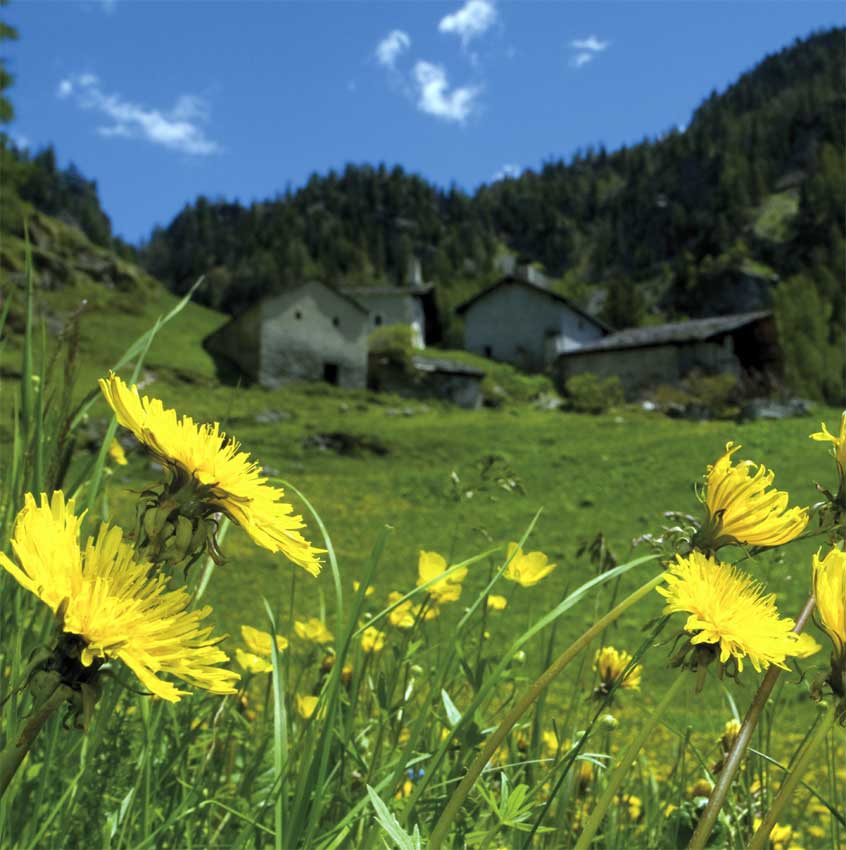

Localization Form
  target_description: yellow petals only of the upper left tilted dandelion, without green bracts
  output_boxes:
[100,372,324,575]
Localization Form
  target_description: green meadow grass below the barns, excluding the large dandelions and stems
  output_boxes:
[0,266,846,850]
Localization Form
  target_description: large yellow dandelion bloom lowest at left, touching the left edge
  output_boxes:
[0,491,238,702]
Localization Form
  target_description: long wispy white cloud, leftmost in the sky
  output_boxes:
[56,74,221,156]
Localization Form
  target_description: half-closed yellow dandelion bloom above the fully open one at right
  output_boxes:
[694,443,808,552]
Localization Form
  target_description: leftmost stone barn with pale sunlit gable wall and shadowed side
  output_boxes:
[203,281,370,388]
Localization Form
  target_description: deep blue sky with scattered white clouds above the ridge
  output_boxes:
[6,0,846,242]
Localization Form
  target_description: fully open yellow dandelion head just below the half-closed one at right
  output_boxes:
[656,552,816,672]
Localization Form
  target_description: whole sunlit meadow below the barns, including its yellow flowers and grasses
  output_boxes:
[0,262,846,850]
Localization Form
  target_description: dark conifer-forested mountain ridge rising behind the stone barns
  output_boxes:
[3,28,846,398]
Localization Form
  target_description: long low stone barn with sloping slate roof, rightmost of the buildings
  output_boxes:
[555,312,782,399]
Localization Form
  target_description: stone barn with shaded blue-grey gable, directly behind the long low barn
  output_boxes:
[456,275,608,372]
